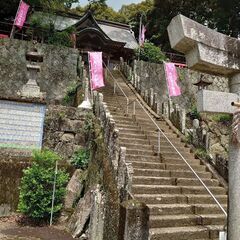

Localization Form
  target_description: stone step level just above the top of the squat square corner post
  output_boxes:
[132,184,226,195]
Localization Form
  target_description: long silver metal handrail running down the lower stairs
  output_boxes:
[115,71,227,217]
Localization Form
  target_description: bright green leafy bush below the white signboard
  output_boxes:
[18,150,68,221]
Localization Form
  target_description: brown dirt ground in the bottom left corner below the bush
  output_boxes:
[0,216,73,240]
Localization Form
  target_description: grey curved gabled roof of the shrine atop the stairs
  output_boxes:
[31,11,138,49]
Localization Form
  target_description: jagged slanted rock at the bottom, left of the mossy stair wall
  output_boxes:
[68,190,92,238]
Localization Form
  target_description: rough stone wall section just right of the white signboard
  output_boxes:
[43,105,88,160]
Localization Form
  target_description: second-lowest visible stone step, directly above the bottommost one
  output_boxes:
[150,214,226,228]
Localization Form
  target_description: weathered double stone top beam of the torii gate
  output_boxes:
[168,15,240,76]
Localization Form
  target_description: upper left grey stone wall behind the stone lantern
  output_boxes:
[0,39,81,102]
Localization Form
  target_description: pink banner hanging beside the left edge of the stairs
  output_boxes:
[88,52,105,90]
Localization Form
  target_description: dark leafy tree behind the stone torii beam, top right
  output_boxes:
[148,0,240,51]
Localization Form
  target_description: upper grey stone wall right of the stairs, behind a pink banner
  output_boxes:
[121,61,229,108]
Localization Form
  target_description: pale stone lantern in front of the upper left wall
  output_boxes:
[20,45,46,99]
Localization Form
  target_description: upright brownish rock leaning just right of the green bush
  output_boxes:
[63,169,83,209]
